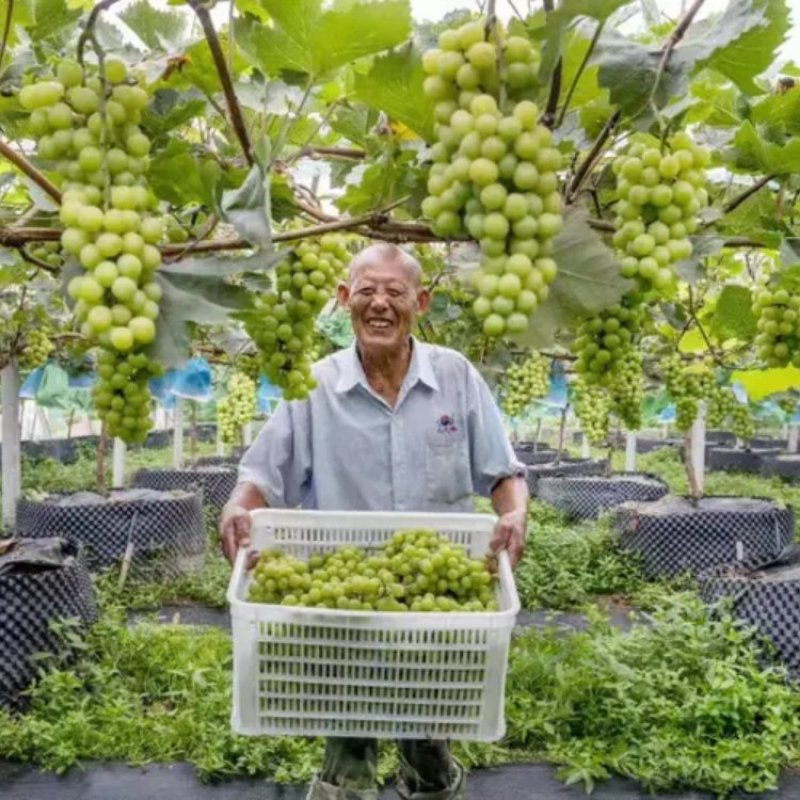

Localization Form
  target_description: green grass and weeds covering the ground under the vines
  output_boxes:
[0,438,800,796]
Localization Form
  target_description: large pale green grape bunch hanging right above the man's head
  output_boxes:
[422,20,563,337]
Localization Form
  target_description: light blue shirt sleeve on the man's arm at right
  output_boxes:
[467,364,525,497]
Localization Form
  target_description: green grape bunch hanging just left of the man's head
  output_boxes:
[245,234,349,400]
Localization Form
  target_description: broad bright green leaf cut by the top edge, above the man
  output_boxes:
[235,0,411,76]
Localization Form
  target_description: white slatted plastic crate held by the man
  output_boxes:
[228,509,519,741]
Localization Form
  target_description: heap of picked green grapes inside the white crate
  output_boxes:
[248,530,497,612]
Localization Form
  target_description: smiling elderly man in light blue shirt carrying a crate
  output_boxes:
[221,244,528,800]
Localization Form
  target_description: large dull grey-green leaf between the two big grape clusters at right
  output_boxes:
[515,209,632,348]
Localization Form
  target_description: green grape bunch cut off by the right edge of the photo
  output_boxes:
[753,286,800,367]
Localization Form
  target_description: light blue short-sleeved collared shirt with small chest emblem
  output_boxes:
[239,339,525,512]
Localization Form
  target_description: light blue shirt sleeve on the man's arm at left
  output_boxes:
[239,400,311,508]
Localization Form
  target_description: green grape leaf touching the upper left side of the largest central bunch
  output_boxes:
[353,45,434,142]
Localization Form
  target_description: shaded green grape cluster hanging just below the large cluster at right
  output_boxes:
[572,304,645,430]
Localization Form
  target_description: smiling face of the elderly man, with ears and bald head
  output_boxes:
[338,248,429,353]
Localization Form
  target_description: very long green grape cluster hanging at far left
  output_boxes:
[19,59,164,442]
